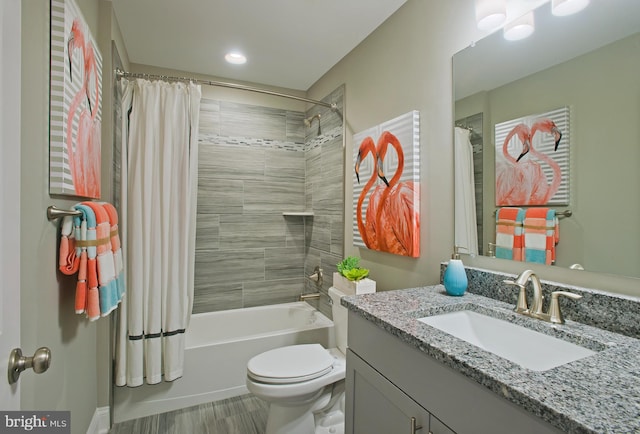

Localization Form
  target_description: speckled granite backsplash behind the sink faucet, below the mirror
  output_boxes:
[440,262,640,339]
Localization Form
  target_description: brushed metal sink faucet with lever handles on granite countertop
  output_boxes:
[503,270,582,324]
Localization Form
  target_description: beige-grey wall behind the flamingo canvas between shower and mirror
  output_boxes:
[307,0,638,295]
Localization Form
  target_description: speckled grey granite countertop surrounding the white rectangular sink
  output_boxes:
[342,285,640,433]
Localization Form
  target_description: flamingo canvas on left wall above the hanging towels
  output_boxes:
[49,0,102,199]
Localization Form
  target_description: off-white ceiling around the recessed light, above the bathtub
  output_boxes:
[112,0,406,91]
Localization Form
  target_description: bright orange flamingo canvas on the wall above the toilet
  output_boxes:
[353,111,420,258]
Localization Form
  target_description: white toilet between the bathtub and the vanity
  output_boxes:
[247,287,347,434]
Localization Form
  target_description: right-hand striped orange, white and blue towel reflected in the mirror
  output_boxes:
[524,208,560,265]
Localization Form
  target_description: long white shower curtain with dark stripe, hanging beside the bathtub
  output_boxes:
[115,79,201,386]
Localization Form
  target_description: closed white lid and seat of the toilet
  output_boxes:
[247,344,334,384]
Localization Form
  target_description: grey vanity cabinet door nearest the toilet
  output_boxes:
[346,351,429,434]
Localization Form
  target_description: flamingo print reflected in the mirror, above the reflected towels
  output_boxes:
[495,107,571,206]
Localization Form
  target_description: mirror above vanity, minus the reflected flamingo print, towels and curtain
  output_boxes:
[453,0,640,277]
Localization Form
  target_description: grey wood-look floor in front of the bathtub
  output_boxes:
[109,394,269,434]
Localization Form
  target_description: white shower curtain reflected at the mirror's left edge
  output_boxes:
[454,127,478,255]
